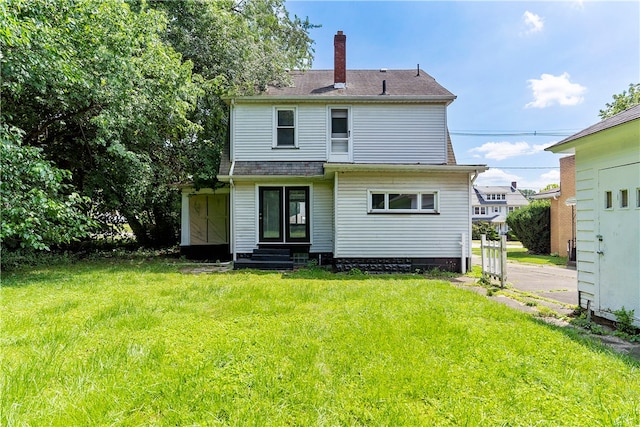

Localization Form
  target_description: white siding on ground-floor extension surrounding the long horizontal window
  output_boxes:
[334,173,470,258]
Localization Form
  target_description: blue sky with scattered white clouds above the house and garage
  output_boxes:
[286,0,640,191]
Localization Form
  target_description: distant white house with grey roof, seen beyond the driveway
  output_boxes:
[471,182,529,234]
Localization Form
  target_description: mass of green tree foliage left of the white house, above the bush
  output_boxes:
[0,0,312,249]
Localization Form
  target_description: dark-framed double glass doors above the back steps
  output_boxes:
[258,187,310,243]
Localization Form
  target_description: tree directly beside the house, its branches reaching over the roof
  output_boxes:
[144,0,313,187]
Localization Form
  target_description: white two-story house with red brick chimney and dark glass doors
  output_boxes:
[182,32,486,271]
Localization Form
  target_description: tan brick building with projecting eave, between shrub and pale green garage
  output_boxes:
[531,156,576,265]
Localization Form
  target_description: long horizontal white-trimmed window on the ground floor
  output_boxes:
[369,190,438,213]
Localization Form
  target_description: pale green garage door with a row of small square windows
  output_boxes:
[595,163,640,319]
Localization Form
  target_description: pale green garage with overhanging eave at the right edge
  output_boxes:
[546,105,640,325]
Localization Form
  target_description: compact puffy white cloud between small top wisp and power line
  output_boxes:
[525,72,587,108]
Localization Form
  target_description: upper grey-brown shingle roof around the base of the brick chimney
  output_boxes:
[261,70,455,100]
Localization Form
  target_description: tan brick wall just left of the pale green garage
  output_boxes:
[551,156,576,256]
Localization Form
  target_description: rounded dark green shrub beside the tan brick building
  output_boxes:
[507,200,551,254]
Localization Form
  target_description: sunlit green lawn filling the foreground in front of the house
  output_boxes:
[0,261,640,426]
